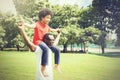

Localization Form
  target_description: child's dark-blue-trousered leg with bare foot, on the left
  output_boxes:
[39,42,49,77]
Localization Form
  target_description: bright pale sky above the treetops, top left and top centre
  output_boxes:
[0,0,92,15]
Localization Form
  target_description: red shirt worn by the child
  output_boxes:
[33,21,50,45]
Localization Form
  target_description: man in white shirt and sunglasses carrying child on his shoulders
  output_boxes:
[18,21,61,80]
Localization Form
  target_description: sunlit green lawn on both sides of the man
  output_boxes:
[0,51,120,80]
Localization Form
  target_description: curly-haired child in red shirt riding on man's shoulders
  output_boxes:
[19,9,60,77]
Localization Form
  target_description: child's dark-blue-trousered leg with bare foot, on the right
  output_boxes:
[50,45,61,72]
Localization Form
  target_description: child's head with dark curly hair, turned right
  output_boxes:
[38,9,53,24]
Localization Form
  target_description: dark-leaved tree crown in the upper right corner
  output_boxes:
[92,0,120,52]
